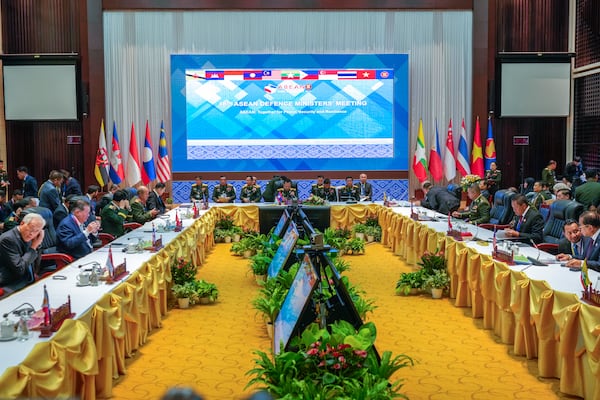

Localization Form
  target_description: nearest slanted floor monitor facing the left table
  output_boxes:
[273,255,318,354]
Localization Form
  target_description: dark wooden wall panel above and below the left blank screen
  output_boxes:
[1,0,85,188]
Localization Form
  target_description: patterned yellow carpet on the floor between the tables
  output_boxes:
[113,244,568,400]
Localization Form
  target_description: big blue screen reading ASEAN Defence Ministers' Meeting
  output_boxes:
[171,54,409,172]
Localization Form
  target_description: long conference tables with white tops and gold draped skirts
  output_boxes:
[0,202,600,399]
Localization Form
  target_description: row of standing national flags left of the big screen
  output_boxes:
[94,120,171,186]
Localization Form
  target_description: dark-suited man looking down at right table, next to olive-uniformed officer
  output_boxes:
[504,194,544,243]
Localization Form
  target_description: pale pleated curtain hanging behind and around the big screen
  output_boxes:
[103,11,474,189]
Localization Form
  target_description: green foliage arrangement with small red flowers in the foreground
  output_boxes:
[247,321,413,400]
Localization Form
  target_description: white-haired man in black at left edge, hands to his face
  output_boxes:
[0,213,46,290]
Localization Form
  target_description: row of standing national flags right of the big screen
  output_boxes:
[413,117,496,182]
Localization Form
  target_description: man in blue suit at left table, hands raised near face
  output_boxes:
[56,197,100,259]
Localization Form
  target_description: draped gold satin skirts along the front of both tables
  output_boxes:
[0,204,600,399]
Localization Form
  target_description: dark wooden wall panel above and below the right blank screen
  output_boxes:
[490,0,569,186]
